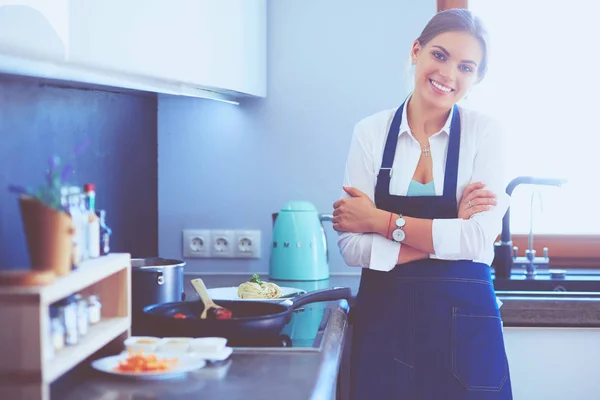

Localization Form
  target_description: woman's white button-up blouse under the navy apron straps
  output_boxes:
[338,101,510,271]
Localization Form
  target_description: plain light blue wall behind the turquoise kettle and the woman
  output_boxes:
[158,0,436,273]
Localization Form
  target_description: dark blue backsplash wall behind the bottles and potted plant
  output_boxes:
[0,76,158,269]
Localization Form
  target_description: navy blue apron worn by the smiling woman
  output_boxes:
[351,106,512,400]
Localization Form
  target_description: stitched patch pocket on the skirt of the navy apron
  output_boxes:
[452,307,508,392]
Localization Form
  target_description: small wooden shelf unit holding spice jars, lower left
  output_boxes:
[0,253,131,400]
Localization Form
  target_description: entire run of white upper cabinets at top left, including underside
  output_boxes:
[0,0,267,97]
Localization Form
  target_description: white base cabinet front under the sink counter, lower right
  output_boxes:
[504,327,600,400]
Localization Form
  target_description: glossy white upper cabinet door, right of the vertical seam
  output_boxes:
[69,0,267,96]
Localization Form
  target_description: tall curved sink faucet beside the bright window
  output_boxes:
[492,176,567,279]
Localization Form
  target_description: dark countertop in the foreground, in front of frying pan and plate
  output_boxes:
[52,300,348,400]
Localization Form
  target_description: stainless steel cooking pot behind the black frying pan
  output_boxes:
[131,257,185,334]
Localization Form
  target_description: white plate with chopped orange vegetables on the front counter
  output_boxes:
[92,353,206,379]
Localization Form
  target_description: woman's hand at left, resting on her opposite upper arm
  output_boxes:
[332,186,379,233]
